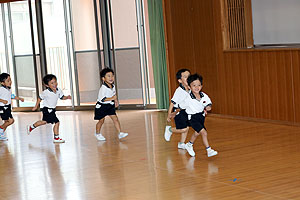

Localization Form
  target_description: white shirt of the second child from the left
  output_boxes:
[40,88,64,108]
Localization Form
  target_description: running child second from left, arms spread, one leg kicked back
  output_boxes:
[27,74,71,143]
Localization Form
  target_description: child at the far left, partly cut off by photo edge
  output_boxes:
[0,73,24,140]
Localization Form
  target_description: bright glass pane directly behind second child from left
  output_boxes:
[42,0,74,106]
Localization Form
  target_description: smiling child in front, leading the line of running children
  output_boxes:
[182,74,218,157]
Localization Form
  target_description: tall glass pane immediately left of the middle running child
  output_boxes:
[72,0,102,105]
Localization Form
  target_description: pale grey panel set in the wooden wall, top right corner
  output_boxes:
[252,0,300,44]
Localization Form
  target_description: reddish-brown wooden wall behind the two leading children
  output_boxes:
[165,0,300,123]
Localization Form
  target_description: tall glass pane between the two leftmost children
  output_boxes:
[10,1,37,107]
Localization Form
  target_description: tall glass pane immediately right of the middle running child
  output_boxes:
[111,0,143,104]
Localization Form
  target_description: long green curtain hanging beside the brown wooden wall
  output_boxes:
[148,0,169,109]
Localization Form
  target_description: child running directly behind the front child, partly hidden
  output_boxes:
[165,69,190,149]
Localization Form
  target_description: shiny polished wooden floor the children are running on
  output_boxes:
[0,111,300,200]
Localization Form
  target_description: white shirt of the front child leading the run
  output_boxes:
[182,92,212,116]
